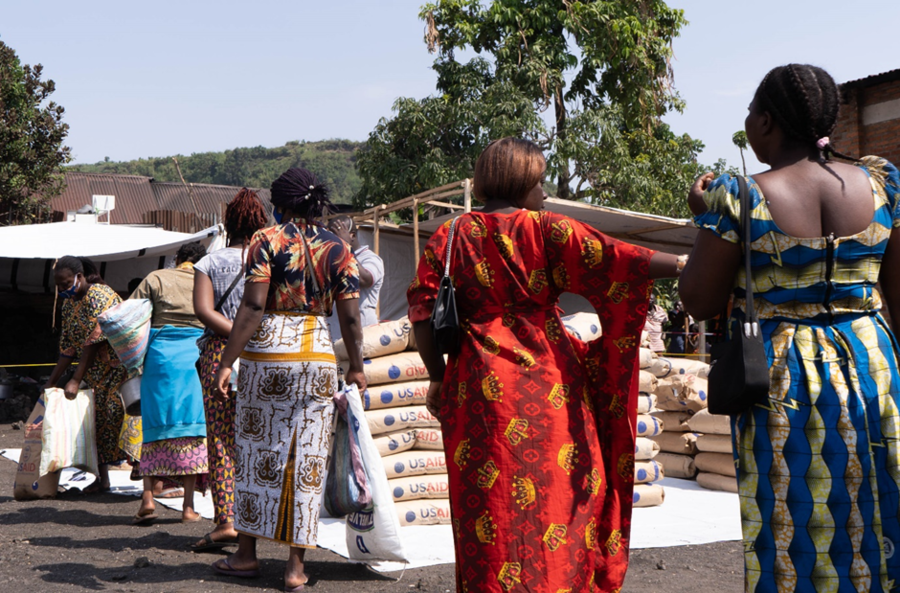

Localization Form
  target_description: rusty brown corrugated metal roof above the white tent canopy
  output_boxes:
[51,172,272,224]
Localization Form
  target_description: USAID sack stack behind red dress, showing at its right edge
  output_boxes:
[562,313,665,507]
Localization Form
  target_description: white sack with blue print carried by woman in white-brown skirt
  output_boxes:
[344,384,408,564]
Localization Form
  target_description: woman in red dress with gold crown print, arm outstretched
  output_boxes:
[407,138,679,593]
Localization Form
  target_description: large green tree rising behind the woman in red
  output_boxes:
[357,0,702,214]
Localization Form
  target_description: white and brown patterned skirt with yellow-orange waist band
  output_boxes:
[234,312,337,548]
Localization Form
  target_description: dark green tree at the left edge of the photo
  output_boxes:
[0,41,70,224]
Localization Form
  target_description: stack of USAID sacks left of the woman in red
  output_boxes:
[335,318,450,525]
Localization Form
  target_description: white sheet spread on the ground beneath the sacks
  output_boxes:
[0,449,741,572]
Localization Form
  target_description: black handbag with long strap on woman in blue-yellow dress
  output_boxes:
[708,176,769,415]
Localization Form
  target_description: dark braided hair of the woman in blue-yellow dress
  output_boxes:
[754,64,858,161]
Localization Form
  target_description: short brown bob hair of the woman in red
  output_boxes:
[474,138,547,205]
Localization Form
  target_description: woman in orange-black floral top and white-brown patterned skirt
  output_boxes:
[213,168,366,591]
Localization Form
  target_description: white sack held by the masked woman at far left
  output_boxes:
[39,388,99,476]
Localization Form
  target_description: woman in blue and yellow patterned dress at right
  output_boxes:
[680,64,900,591]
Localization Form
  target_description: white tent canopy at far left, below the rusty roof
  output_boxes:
[0,222,219,261]
